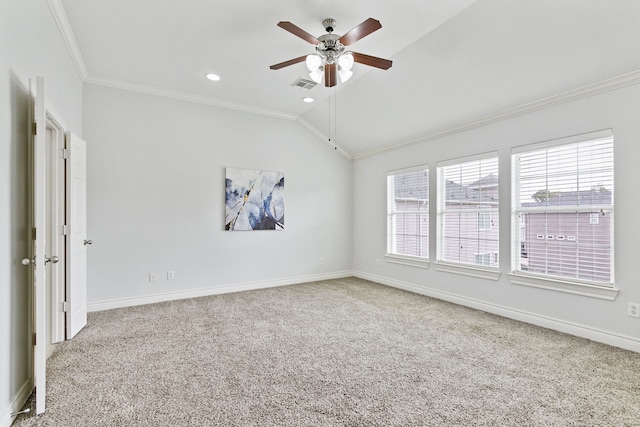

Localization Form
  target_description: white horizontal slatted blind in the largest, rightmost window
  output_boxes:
[512,131,614,286]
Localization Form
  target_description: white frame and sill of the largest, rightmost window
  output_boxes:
[508,129,619,300]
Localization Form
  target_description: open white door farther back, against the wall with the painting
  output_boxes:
[66,132,91,339]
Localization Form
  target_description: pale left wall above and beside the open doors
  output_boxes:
[0,0,82,426]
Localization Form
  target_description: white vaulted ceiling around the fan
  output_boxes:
[60,0,640,157]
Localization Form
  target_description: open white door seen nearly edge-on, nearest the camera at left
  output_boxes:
[22,77,48,414]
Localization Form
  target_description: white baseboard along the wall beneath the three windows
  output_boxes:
[353,272,640,353]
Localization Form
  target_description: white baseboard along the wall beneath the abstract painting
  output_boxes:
[87,271,353,312]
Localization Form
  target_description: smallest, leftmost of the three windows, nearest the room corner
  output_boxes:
[387,167,429,259]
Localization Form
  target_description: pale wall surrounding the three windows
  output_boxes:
[354,85,640,351]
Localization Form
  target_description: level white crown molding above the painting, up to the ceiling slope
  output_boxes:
[84,77,297,120]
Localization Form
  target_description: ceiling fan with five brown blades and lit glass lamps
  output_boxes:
[269,18,392,87]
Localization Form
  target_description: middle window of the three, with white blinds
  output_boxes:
[437,153,499,268]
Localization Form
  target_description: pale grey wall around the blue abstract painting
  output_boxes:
[84,84,352,309]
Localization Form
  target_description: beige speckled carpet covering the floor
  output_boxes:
[14,278,640,426]
